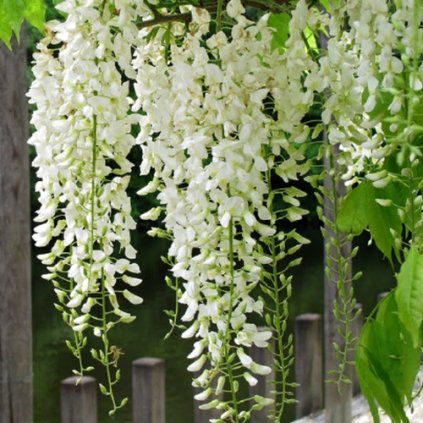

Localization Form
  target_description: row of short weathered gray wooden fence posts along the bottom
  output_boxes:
[61,306,374,423]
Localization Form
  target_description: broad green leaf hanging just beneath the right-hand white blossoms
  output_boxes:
[337,180,402,260]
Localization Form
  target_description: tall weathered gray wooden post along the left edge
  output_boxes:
[0,29,33,423]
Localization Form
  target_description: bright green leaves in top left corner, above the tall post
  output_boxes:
[0,0,46,48]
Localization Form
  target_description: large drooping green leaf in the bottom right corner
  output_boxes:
[356,293,420,423]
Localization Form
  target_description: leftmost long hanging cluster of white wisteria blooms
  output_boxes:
[29,0,142,384]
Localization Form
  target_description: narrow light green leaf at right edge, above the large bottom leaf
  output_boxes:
[395,246,423,347]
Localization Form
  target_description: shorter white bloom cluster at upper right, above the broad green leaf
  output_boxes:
[319,0,423,188]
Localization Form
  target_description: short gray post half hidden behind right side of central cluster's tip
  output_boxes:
[249,327,275,423]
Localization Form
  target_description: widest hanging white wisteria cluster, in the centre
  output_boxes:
[133,0,317,419]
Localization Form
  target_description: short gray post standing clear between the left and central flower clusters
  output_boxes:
[132,357,166,423]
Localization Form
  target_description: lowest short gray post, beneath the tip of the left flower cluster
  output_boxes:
[60,376,97,423]
